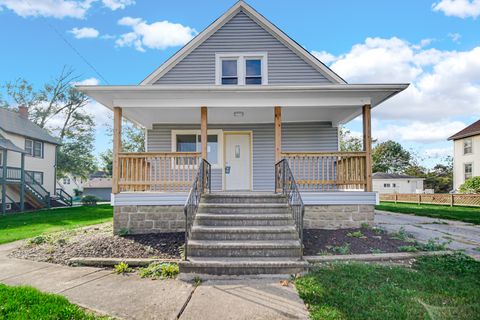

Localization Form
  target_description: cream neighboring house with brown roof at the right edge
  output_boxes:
[448,120,480,190]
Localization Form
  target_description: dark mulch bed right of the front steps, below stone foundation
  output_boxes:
[303,228,412,256]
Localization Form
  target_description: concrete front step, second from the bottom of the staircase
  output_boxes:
[188,240,302,258]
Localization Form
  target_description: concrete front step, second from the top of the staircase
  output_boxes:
[198,202,289,214]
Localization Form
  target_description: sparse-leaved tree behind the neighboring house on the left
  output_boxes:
[3,67,95,177]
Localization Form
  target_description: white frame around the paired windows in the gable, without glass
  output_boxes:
[215,52,268,86]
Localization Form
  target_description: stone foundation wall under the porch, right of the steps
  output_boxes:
[303,205,375,229]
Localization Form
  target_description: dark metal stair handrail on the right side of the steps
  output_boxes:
[275,159,305,252]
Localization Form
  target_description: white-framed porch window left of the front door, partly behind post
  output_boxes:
[172,130,222,166]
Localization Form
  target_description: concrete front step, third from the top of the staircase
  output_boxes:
[194,213,294,227]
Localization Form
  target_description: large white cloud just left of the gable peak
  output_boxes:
[115,17,197,52]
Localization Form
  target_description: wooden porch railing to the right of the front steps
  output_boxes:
[282,152,367,191]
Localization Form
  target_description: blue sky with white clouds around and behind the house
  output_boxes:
[0,0,480,165]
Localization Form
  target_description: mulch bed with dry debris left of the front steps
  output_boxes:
[11,223,185,264]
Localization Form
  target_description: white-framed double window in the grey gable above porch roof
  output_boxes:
[215,53,268,85]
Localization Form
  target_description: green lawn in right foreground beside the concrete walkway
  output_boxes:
[296,254,480,320]
